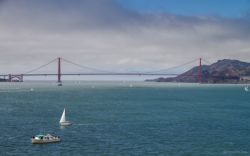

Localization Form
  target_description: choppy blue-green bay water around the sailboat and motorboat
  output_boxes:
[0,82,250,156]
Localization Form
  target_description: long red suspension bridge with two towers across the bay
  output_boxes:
[0,57,210,84]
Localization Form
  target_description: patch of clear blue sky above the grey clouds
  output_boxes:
[120,0,250,18]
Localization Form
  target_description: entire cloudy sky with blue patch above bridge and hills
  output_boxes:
[0,0,250,80]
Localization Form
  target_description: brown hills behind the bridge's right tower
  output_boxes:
[147,59,250,83]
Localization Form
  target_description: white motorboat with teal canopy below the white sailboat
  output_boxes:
[31,134,61,144]
